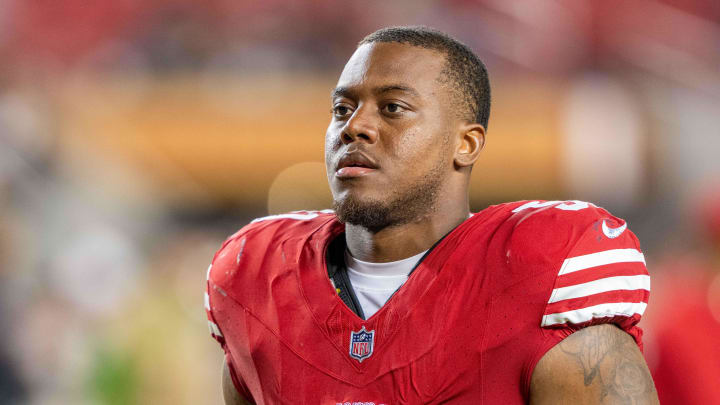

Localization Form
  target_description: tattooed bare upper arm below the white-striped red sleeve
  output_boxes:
[530,325,659,405]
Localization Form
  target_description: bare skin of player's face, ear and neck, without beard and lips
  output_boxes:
[325,43,485,262]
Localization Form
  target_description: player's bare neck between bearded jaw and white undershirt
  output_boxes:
[345,198,470,262]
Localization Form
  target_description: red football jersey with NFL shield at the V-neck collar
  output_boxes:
[205,201,650,405]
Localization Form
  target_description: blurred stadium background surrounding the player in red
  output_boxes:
[0,0,720,404]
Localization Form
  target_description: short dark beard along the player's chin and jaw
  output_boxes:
[333,165,442,232]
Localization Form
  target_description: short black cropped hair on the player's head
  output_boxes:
[358,26,490,129]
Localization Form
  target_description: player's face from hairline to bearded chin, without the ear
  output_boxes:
[325,42,457,229]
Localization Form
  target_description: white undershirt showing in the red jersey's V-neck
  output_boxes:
[345,250,427,319]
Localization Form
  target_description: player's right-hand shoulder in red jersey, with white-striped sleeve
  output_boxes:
[476,200,650,332]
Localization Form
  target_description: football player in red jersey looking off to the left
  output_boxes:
[205,27,657,405]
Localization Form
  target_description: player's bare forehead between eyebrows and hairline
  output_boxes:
[337,42,445,95]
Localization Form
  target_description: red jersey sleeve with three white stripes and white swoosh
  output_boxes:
[540,207,650,347]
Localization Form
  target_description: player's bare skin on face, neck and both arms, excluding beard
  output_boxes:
[223,43,658,404]
